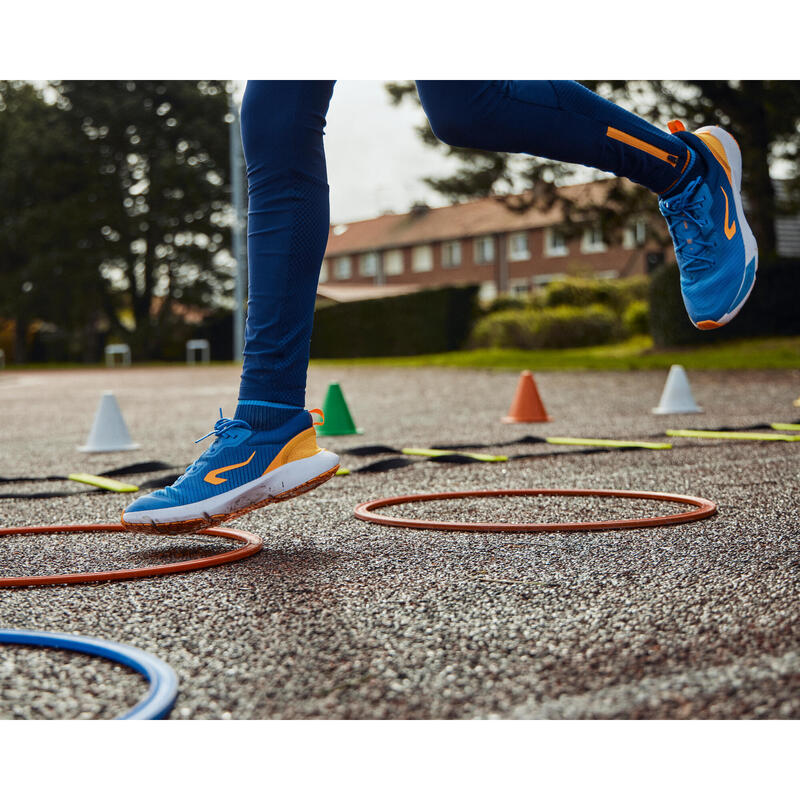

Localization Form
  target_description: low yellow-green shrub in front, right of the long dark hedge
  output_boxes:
[470,304,624,350]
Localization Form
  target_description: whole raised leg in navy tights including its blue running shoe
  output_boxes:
[417,81,758,330]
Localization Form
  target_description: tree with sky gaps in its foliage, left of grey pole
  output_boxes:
[55,81,233,358]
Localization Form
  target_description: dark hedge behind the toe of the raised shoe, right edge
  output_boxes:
[650,260,800,347]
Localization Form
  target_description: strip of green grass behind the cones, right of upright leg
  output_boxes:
[312,336,800,372]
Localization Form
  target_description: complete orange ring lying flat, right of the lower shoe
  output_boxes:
[355,489,717,533]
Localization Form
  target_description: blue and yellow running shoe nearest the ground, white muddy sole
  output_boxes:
[122,409,339,533]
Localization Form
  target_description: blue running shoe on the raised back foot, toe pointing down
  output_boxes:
[658,121,758,330]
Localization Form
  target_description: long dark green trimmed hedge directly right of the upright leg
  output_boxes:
[311,285,478,358]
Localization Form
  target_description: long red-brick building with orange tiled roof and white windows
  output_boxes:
[319,181,666,300]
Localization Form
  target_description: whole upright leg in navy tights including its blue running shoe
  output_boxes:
[122,81,339,533]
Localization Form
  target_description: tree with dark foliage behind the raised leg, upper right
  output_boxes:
[386,81,800,257]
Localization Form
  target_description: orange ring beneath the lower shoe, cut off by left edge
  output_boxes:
[0,524,264,588]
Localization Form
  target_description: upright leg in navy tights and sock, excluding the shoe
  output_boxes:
[236,81,334,428]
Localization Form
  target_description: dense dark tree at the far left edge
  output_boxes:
[0,81,101,362]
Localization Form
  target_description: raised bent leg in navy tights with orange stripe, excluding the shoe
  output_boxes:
[417,81,700,194]
